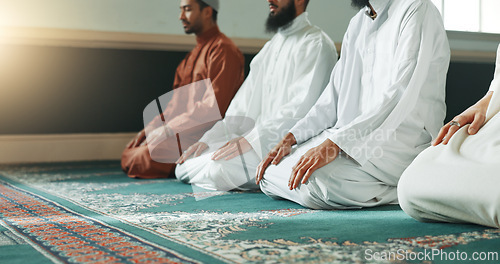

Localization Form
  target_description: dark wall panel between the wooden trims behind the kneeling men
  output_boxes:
[0,45,494,135]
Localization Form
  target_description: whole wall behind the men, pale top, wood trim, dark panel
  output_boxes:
[0,0,500,163]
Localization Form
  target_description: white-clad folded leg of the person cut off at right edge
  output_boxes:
[398,144,500,227]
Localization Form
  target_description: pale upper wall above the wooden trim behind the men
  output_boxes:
[0,0,500,52]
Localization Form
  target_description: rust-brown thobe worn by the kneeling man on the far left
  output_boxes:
[121,26,244,179]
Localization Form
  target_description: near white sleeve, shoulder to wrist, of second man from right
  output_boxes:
[329,3,450,165]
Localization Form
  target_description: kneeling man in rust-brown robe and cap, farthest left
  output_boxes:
[121,0,244,179]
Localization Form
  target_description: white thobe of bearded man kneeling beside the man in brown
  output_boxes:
[176,13,337,190]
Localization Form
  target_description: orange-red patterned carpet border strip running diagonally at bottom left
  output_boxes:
[0,184,198,263]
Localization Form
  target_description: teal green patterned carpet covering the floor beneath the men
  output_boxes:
[0,162,500,264]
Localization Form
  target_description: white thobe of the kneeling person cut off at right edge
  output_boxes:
[398,43,500,228]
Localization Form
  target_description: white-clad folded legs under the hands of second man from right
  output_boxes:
[260,136,397,209]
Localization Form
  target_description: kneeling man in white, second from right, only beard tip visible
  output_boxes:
[257,0,450,209]
